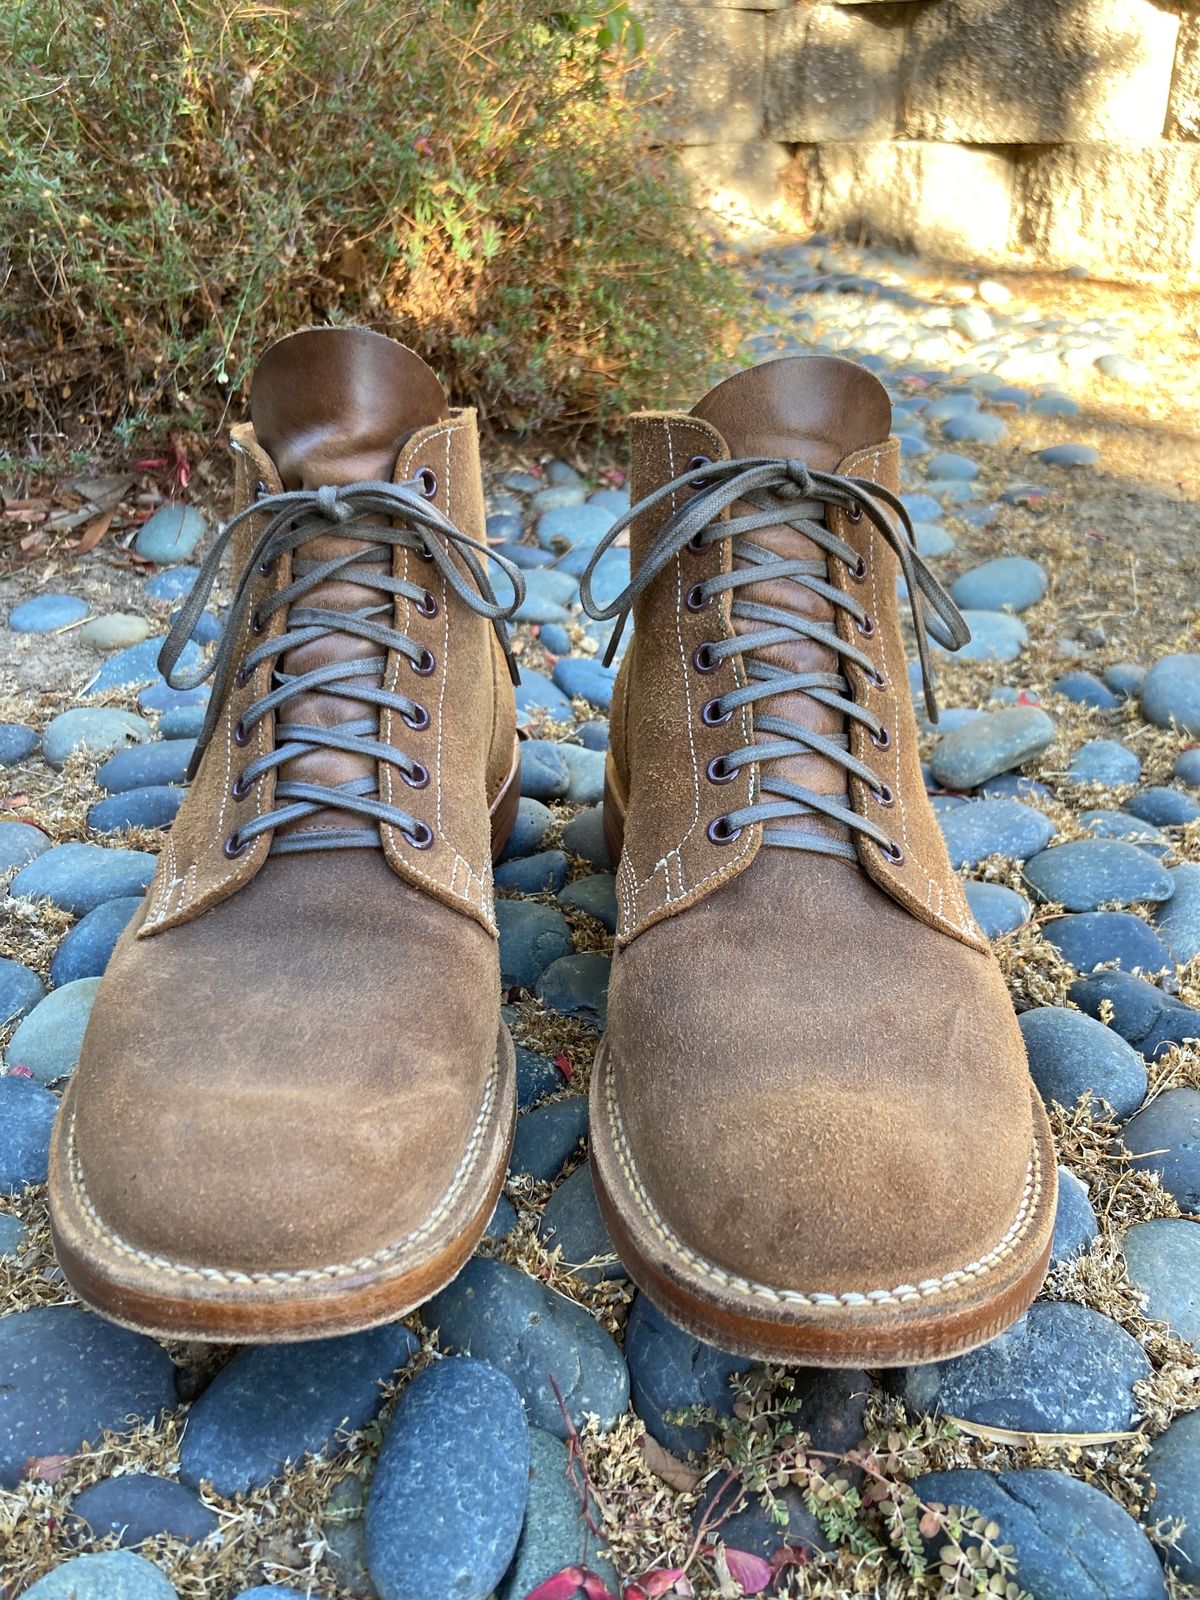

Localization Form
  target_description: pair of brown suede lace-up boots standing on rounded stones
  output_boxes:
[50,330,1054,1366]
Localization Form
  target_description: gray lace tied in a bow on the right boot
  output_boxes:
[579,456,971,861]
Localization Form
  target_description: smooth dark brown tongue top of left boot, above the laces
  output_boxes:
[250,328,450,490]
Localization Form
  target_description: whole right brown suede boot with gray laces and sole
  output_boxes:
[582,357,1054,1366]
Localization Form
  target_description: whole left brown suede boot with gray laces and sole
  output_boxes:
[50,330,523,1341]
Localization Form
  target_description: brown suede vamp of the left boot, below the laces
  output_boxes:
[72,850,499,1272]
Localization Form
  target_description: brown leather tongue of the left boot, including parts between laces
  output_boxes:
[250,328,450,837]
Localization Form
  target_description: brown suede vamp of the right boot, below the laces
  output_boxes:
[608,850,1032,1294]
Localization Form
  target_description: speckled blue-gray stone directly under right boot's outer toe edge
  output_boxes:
[899,1301,1150,1434]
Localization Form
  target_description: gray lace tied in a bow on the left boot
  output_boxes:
[158,475,525,856]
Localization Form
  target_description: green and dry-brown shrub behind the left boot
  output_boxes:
[0,0,738,438]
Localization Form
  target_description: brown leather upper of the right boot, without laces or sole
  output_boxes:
[608,357,1034,1294]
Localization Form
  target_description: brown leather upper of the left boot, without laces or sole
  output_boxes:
[69,330,515,1274]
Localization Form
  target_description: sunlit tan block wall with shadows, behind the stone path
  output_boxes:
[642,0,1200,280]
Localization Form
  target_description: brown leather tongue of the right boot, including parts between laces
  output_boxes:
[691,355,891,857]
